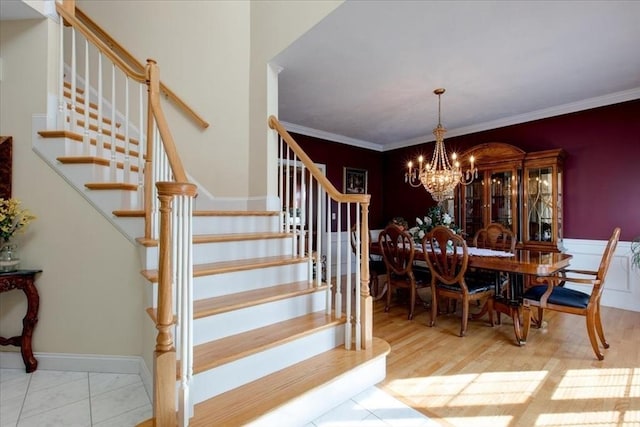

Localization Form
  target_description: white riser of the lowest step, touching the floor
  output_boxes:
[246,356,384,427]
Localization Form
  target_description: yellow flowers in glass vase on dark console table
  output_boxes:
[0,198,36,271]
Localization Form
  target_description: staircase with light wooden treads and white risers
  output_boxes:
[33,1,390,426]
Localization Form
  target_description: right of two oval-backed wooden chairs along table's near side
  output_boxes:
[422,226,495,337]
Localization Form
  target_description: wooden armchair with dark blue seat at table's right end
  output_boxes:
[522,227,620,360]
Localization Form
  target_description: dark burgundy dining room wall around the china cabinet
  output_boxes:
[295,100,640,241]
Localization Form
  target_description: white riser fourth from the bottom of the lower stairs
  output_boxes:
[193,262,308,300]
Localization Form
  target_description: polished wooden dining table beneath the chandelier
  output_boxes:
[370,243,573,345]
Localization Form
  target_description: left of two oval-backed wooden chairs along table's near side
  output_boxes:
[378,224,424,320]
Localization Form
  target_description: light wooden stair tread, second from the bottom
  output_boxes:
[193,311,346,374]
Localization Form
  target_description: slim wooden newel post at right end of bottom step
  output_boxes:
[360,203,373,349]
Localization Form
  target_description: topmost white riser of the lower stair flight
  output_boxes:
[193,216,278,234]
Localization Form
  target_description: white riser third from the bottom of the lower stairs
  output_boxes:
[193,291,327,345]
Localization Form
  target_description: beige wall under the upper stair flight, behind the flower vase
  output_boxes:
[0,19,148,356]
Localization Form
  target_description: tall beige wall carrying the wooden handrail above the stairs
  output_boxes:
[77,0,250,197]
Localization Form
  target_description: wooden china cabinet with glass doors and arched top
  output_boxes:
[454,142,564,251]
